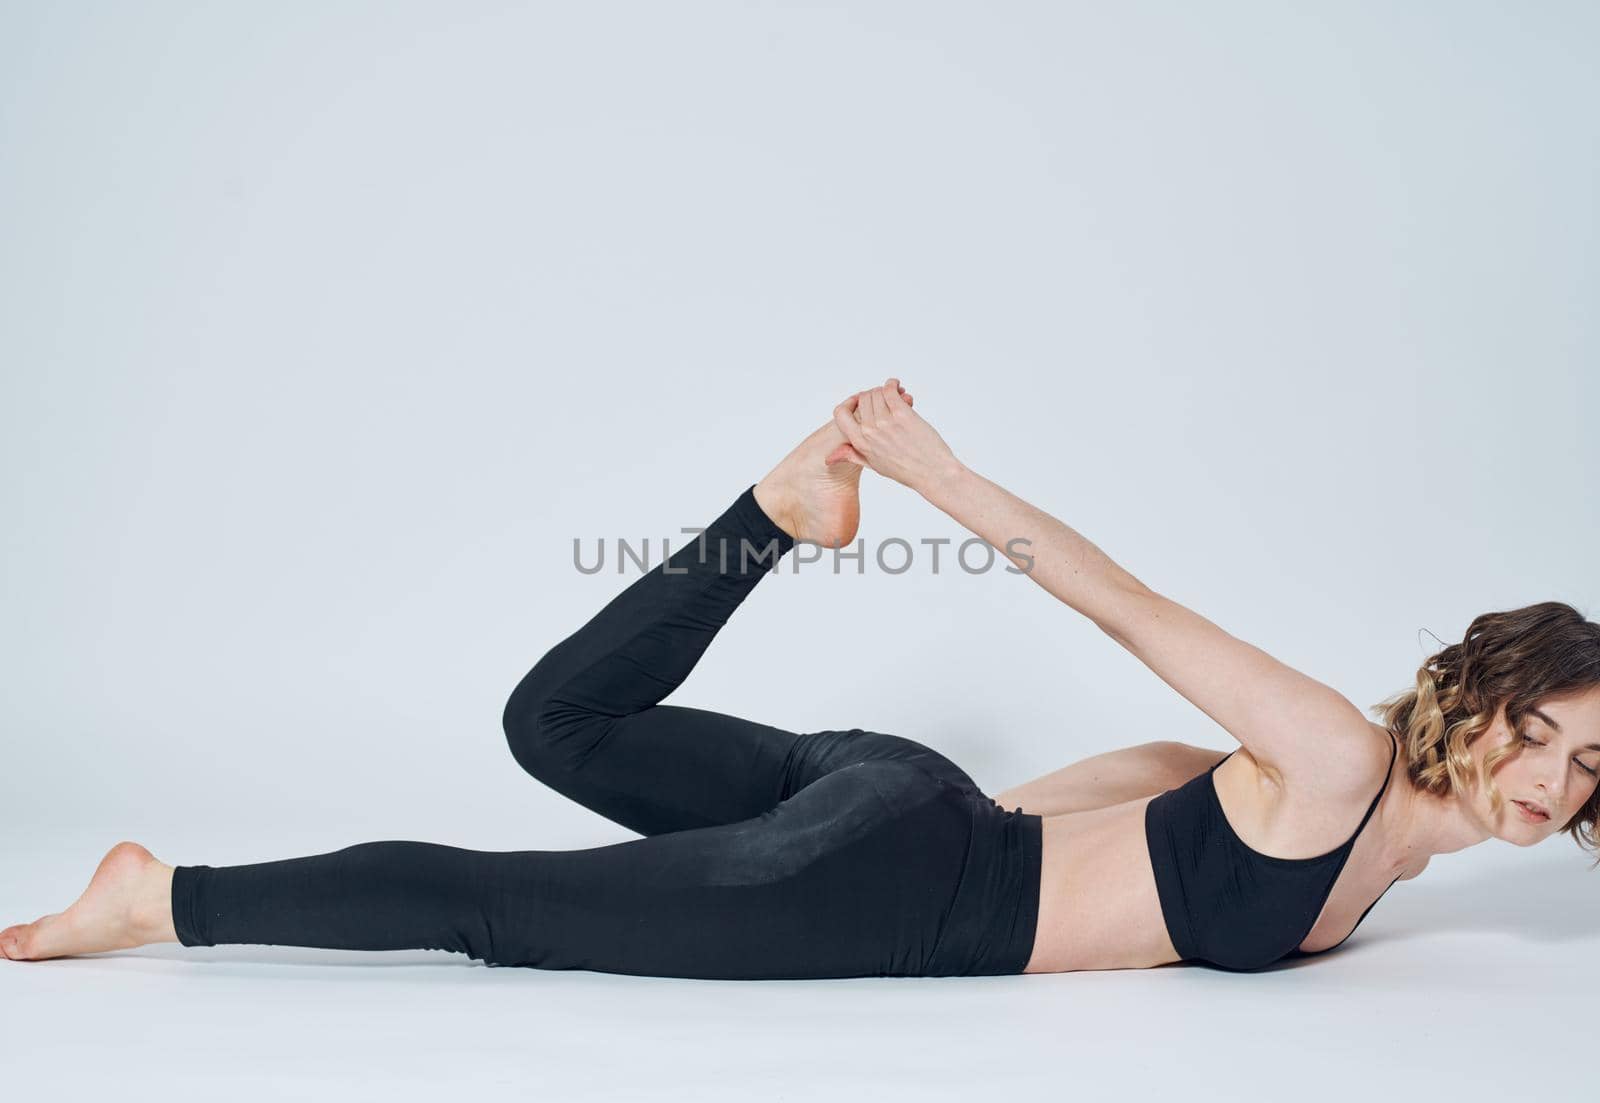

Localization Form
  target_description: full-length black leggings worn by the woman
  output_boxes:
[171,487,1040,980]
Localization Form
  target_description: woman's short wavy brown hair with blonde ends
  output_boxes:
[1371,602,1600,869]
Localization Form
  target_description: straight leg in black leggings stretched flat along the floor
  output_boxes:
[173,762,974,980]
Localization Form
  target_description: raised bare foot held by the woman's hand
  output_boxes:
[755,387,912,547]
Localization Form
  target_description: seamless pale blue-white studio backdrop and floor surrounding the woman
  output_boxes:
[0,2,1600,1100]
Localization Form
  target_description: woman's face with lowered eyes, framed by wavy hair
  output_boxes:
[1472,690,1600,847]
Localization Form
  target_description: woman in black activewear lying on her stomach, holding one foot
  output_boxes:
[0,378,1600,978]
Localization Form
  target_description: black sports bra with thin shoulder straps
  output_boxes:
[1144,733,1398,972]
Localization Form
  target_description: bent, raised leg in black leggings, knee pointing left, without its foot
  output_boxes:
[504,485,800,834]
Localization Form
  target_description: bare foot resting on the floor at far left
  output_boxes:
[0,842,178,961]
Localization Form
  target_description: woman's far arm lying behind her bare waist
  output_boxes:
[995,740,1227,816]
